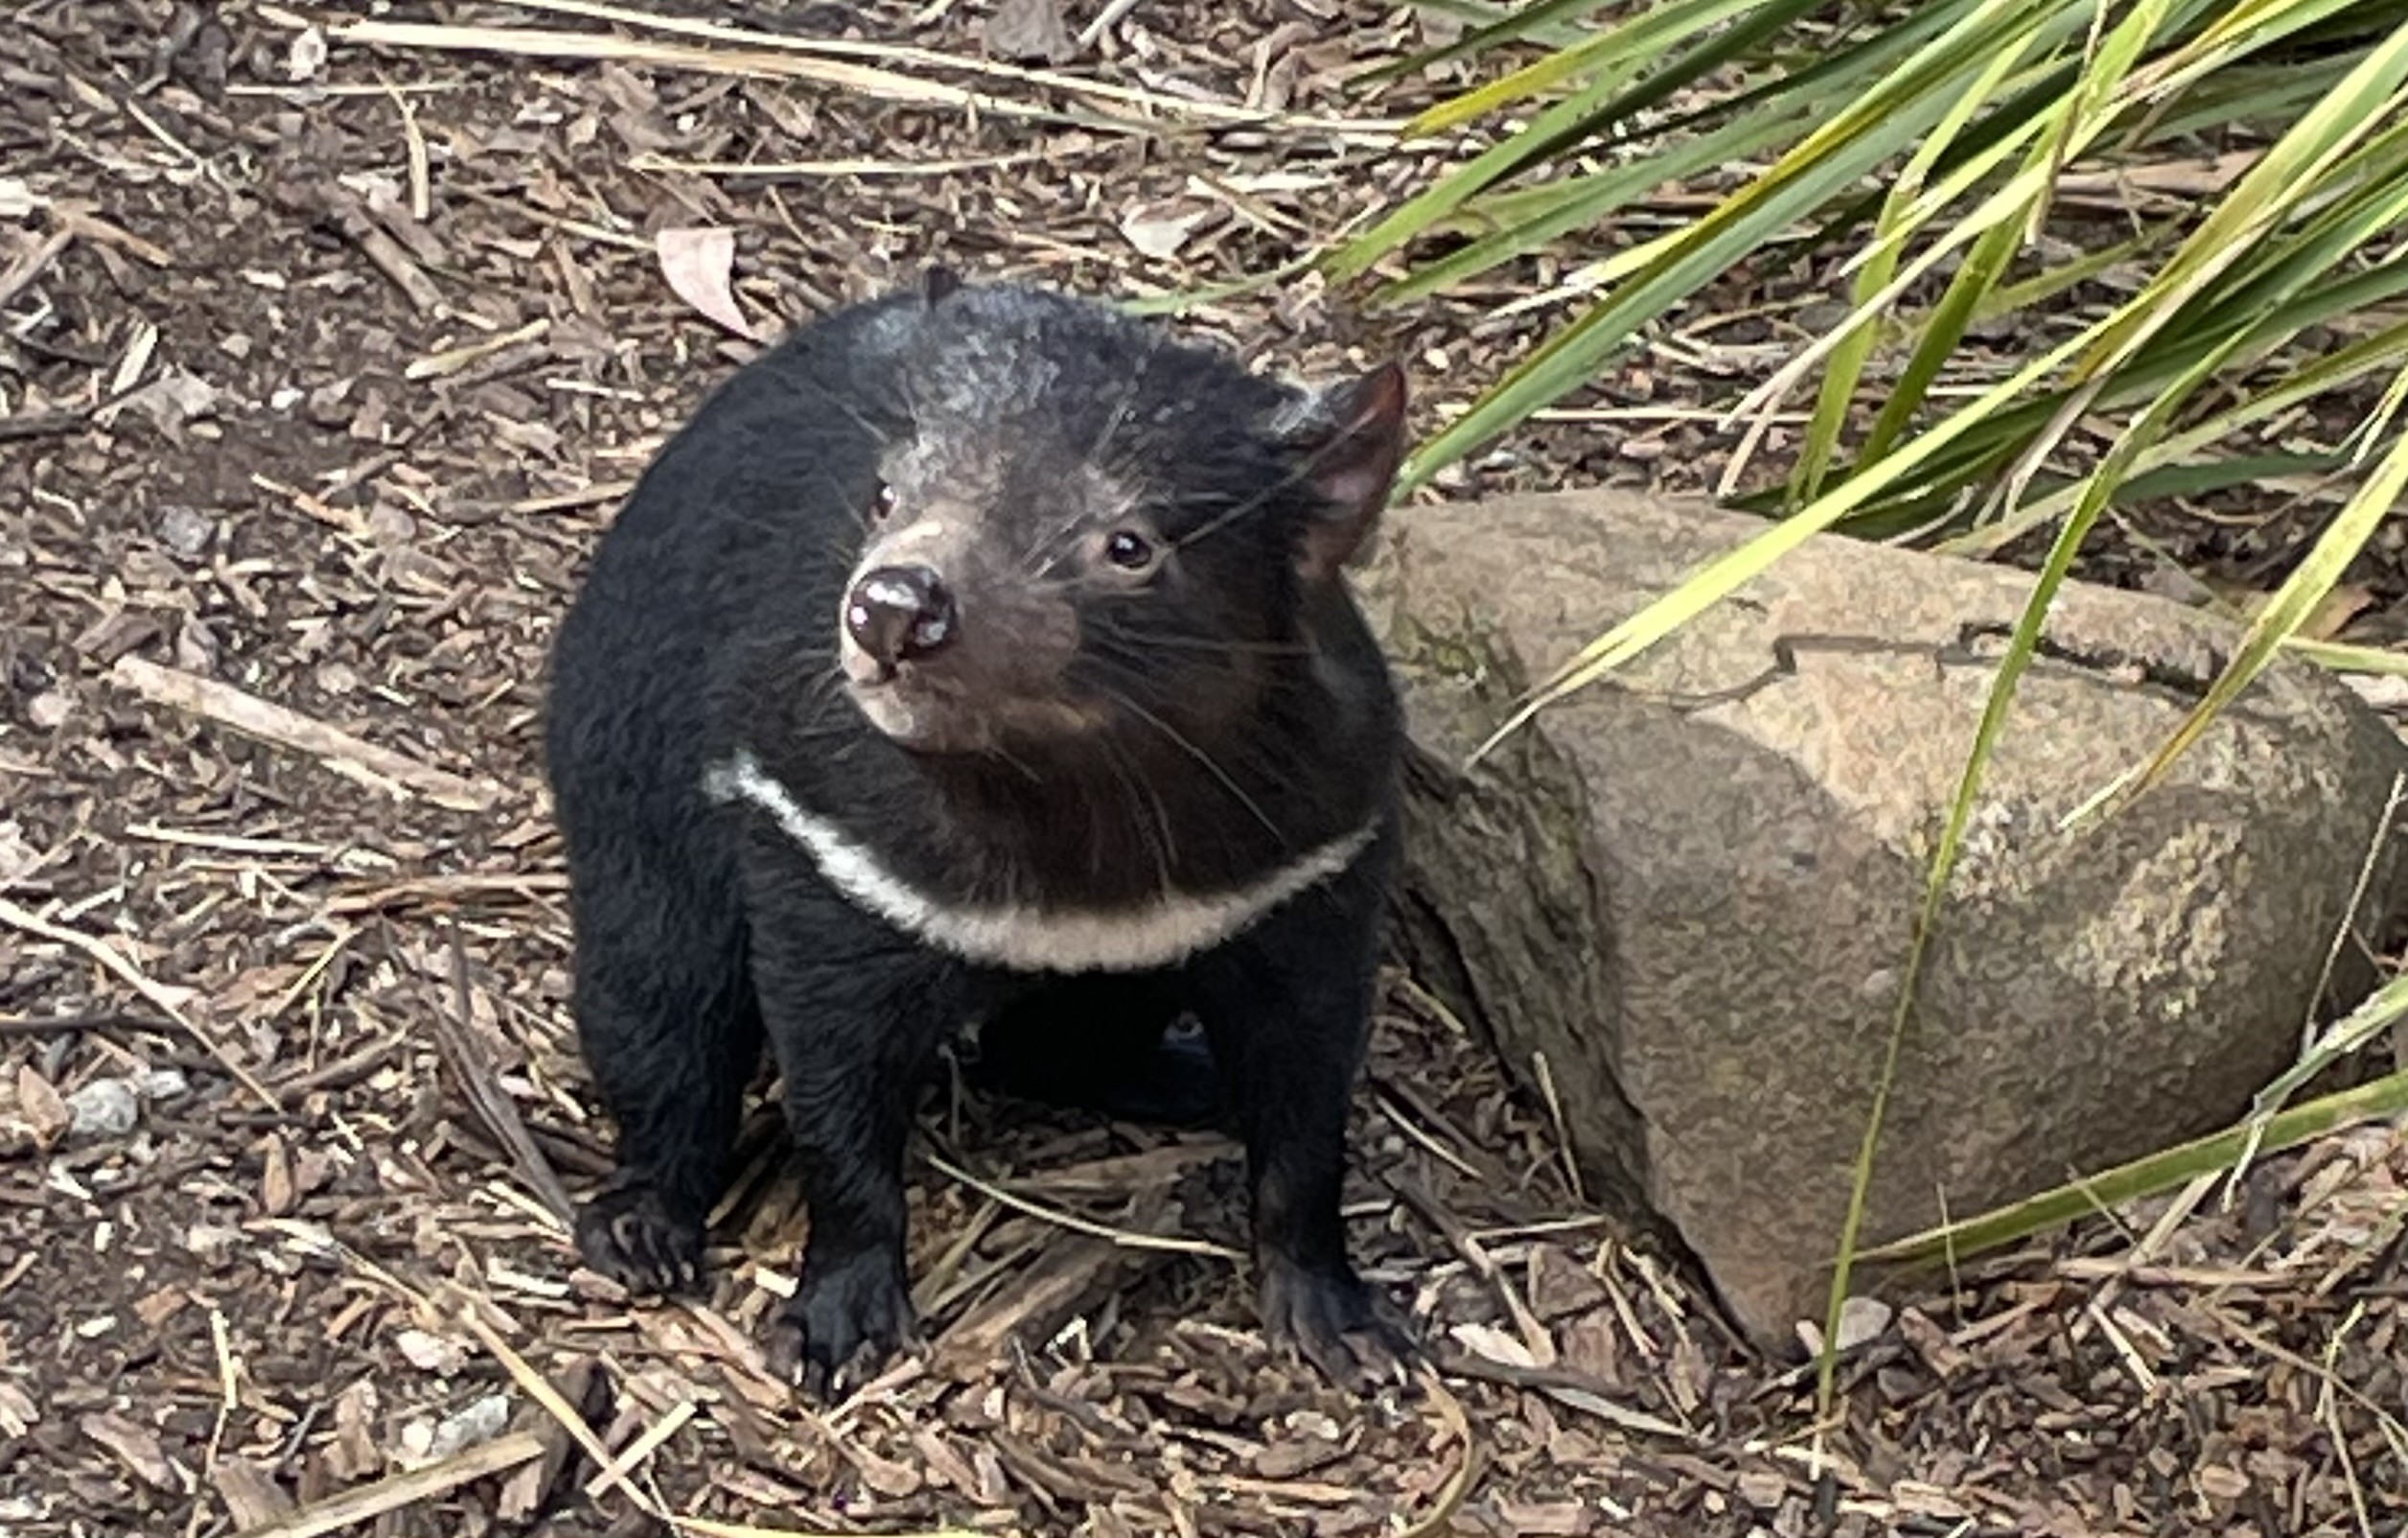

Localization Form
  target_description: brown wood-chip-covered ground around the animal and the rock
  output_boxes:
[0,0,2408,1538]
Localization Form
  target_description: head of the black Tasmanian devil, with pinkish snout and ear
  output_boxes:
[828,274,1403,758]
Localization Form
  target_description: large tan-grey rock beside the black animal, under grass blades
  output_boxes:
[1360,491,2408,1350]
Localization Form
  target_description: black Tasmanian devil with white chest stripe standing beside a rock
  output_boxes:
[546,269,1409,1393]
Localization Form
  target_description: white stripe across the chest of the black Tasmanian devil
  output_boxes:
[704,751,1375,972]
